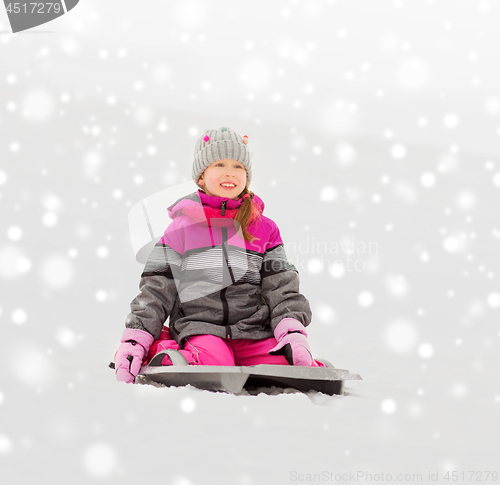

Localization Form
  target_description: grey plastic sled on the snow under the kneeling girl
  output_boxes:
[110,350,362,396]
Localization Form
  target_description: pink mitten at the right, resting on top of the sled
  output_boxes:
[268,318,314,366]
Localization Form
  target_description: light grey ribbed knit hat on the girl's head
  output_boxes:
[192,126,252,188]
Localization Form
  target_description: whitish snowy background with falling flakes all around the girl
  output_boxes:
[0,0,500,485]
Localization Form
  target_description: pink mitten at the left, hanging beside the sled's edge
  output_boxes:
[115,328,154,383]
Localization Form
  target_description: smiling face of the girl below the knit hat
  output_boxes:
[198,158,247,200]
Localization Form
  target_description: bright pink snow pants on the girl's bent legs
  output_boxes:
[144,329,324,367]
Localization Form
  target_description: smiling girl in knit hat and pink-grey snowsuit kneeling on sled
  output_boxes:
[115,127,323,382]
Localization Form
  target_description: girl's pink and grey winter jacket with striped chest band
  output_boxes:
[126,190,312,345]
